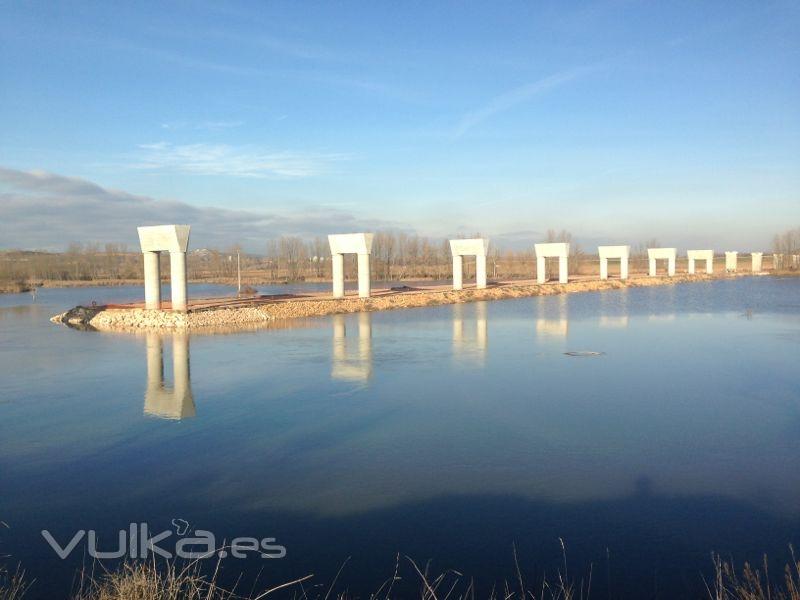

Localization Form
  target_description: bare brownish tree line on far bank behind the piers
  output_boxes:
[0,227,800,284]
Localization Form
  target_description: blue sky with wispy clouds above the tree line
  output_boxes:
[0,1,800,251]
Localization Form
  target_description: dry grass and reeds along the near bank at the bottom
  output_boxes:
[0,551,800,600]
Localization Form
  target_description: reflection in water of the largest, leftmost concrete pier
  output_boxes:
[144,332,196,420]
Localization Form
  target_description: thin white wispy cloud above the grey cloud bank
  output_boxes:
[131,142,348,179]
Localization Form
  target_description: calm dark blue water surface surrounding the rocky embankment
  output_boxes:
[0,277,800,598]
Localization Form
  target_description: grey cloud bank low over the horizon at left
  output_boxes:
[0,167,398,251]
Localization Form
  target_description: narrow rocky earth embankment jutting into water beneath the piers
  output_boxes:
[50,273,769,332]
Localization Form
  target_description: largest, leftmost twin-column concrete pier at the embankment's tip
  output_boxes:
[136,225,191,311]
